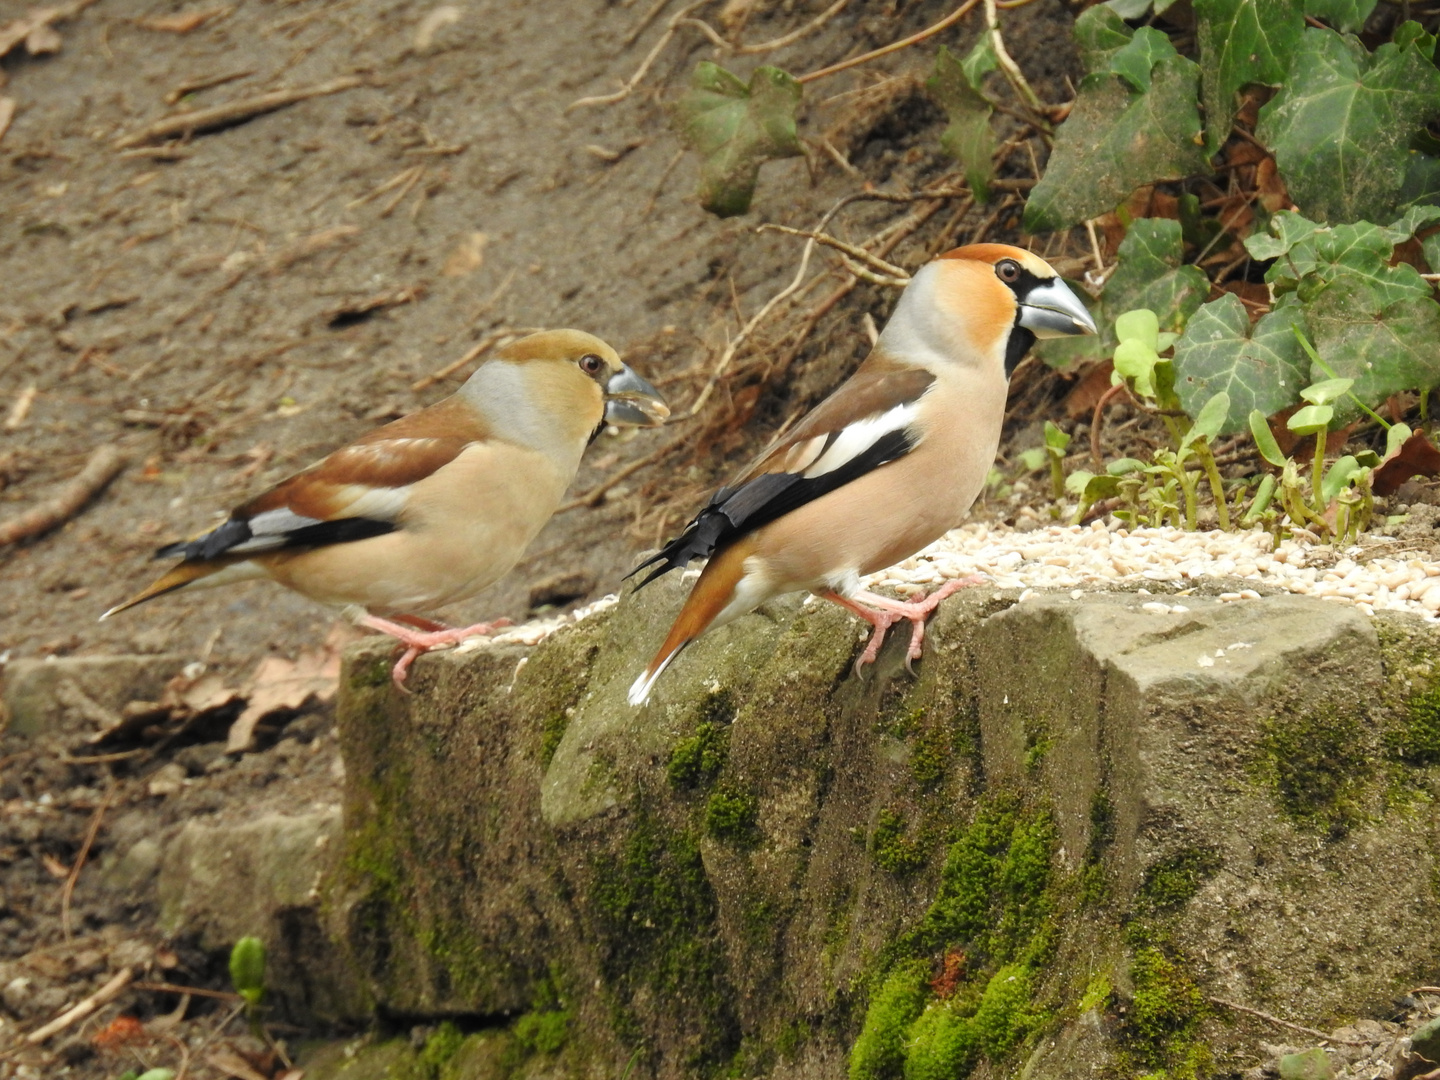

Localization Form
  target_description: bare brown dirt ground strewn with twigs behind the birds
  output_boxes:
[0,0,1100,1077]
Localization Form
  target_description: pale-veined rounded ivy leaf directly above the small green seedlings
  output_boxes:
[1175,292,1310,435]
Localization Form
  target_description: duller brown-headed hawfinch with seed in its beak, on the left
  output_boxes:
[101,330,670,684]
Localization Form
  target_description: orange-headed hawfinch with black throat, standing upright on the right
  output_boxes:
[629,243,1096,714]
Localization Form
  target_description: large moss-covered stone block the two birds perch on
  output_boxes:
[323,587,1440,1080]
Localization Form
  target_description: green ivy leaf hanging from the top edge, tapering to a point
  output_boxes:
[1195,0,1305,154]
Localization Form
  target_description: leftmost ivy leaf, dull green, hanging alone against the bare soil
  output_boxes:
[675,60,801,217]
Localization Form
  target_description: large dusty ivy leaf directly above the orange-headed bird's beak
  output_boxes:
[1024,56,1205,233]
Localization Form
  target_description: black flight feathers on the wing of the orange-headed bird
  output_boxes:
[625,428,917,589]
